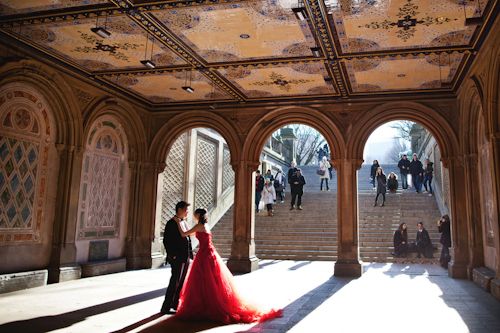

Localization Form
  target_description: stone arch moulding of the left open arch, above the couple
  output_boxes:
[148,111,241,165]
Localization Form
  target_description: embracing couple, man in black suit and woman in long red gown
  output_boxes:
[161,201,282,324]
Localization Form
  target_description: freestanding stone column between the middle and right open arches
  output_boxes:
[332,159,363,277]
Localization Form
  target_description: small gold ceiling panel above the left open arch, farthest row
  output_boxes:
[109,71,233,104]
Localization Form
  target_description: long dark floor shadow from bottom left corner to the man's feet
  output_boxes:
[0,288,166,333]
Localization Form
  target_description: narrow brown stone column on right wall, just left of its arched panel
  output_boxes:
[464,153,484,280]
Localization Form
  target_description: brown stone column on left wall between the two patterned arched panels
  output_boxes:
[48,144,85,283]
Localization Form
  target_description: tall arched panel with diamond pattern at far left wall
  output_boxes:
[0,88,51,244]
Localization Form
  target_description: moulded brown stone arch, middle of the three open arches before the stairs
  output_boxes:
[243,106,344,166]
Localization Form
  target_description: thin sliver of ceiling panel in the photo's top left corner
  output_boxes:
[0,0,103,15]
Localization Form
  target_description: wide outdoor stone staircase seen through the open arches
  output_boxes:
[212,164,441,262]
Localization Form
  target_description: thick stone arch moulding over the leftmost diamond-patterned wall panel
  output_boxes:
[0,60,83,146]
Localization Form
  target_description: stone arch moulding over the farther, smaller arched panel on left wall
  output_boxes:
[80,100,147,161]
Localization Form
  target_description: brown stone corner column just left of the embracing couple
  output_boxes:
[125,161,153,269]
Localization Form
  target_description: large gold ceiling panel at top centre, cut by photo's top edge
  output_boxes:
[153,1,315,63]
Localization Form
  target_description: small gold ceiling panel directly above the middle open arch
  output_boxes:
[219,63,337,99]
